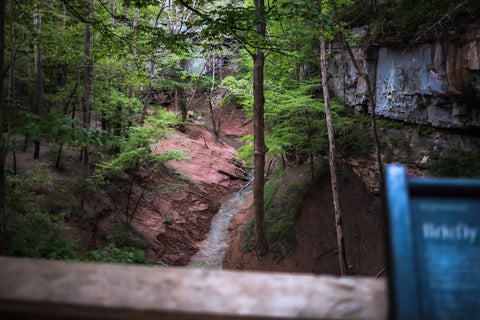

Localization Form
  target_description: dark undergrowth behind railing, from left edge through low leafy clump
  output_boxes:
[4,163,152,264]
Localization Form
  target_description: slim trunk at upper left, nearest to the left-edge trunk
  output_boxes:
[33,8,45,159]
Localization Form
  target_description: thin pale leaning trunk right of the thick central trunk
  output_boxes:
[320,38,347,276]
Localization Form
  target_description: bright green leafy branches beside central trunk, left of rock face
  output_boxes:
[229,68,371,161]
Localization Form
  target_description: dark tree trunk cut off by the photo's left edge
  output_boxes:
[0,0,7,245]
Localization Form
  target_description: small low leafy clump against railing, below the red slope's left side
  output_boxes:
[85,244,153,265]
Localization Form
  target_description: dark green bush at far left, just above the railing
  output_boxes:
[4,168,78,259]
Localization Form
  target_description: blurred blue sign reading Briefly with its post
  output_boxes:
[386,165,480,320]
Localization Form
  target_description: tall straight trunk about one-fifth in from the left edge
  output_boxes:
[83,0,93,178]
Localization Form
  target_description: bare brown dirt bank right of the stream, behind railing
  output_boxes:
[224,167,385,275]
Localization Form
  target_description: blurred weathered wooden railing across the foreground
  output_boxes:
[0,257,387,320]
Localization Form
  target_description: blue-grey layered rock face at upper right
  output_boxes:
[329,25,480,129]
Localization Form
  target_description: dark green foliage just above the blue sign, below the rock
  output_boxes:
[427,149,480,178]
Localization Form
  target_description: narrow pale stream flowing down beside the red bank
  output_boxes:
[190,184,253,269]
